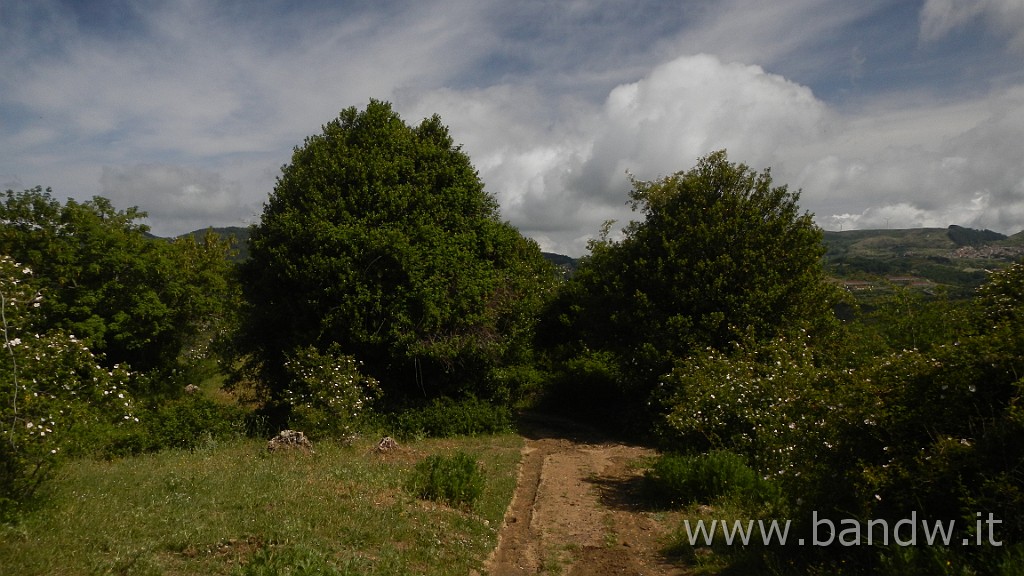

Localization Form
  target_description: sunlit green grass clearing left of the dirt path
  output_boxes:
[0,435,522,576]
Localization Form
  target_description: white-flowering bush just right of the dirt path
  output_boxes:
[654,332,842,476]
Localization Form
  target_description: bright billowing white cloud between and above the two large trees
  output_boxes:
[405,54,829,255]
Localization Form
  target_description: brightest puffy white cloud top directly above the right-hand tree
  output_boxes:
[582,54,827,194]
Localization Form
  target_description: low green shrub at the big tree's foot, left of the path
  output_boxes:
[391,397,512,439]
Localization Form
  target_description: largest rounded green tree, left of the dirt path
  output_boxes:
[238,100,554,402]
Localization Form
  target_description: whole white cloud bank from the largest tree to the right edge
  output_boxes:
[409,50,1024,255]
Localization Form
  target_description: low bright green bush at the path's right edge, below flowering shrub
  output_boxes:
[644,450,780,506]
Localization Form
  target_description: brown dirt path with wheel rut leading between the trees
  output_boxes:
[486,417,687,576]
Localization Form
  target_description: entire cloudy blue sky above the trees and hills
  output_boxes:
[0,0,1024,256]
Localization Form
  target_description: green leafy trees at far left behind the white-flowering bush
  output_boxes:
[0,187,230,385]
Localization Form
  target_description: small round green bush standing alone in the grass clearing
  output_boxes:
[409,452,484,508]
